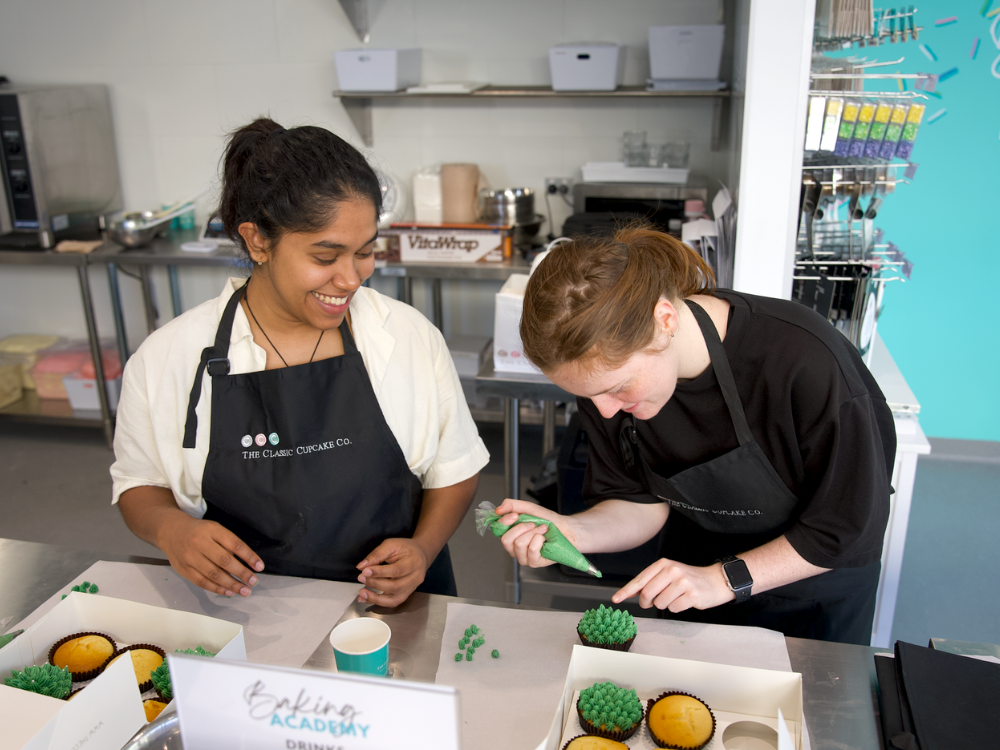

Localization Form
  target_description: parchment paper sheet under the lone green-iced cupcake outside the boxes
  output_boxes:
[435,603,808,750]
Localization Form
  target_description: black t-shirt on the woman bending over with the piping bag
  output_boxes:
[577,290,896,568]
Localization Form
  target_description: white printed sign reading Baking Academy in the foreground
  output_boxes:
[167,654,459,750]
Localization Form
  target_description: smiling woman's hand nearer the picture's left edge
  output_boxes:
[157,511,264,596]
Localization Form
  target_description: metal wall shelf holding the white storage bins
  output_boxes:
[333,86,730,151]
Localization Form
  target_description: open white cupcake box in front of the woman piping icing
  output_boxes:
[536,645,803,750]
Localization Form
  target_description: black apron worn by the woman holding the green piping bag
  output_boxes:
[618,300,881,645]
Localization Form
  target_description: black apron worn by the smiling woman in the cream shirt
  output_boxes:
[184,288,456,596]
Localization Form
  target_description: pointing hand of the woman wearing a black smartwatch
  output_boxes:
[611,559,735,612]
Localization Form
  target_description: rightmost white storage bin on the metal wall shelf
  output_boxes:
[649,24,726,81]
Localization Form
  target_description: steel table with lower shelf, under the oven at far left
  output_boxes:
[0,249,117,445]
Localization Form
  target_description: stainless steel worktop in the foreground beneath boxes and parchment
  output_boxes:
[0,539,883,750]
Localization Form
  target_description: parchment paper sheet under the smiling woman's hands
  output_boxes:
[14,561,361,667]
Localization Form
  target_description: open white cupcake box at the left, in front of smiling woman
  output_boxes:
[0,592,247,750]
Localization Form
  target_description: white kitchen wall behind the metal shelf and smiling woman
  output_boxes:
[0,0,729,346]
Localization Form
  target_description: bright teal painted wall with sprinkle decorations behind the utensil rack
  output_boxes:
[824,0,1000,440]
